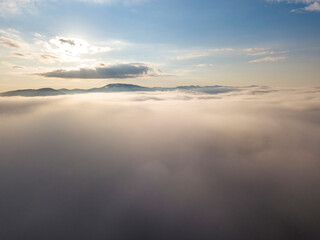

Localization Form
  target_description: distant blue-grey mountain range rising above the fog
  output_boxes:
[0,83,248,97]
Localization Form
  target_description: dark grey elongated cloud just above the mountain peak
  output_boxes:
[37,63,158,79]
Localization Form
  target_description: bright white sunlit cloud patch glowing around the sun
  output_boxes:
[0,29,128,64]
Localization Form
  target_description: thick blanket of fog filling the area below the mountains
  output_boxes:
[0,88,320,240]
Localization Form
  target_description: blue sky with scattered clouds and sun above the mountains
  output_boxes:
[0,0,320,91]
